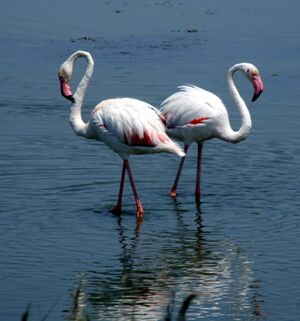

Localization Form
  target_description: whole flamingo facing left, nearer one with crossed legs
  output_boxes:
[58,50,185,218]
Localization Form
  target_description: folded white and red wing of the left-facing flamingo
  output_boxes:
[93,98,183,156]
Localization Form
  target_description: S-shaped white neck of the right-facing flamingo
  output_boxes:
[221,64,252,143]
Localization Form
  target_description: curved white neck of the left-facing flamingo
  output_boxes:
[68,50,94,138]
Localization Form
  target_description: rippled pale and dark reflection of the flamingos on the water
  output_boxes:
[65,203,263,320]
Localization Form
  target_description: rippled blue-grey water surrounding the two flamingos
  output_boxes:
[0,0,300,321]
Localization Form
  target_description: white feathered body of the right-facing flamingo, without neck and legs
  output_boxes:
[161,85,229,145]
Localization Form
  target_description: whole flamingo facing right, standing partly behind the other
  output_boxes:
[160,63,264,200]
